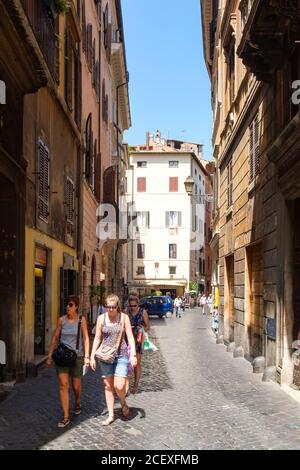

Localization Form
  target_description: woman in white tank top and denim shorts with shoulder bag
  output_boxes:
[90,294,137,426]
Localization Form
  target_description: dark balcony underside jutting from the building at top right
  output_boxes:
[237,0,300,82]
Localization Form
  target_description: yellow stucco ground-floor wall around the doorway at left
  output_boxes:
[24,227,78,360]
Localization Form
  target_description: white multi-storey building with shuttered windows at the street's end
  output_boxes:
[127,132,206,295]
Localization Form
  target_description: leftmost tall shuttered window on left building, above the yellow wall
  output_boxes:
[38,140,50,222]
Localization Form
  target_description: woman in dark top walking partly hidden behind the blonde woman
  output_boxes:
[126,294,150,395]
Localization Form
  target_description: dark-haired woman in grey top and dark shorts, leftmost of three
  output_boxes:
[47,295,90,428]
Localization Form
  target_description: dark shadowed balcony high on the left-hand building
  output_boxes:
[22,0,58,80]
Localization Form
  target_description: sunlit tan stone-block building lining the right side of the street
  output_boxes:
[201,0,300,386]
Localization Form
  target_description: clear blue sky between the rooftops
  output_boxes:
[122,0,212,160]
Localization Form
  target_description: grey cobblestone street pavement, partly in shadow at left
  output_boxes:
[0,309,300,451]
